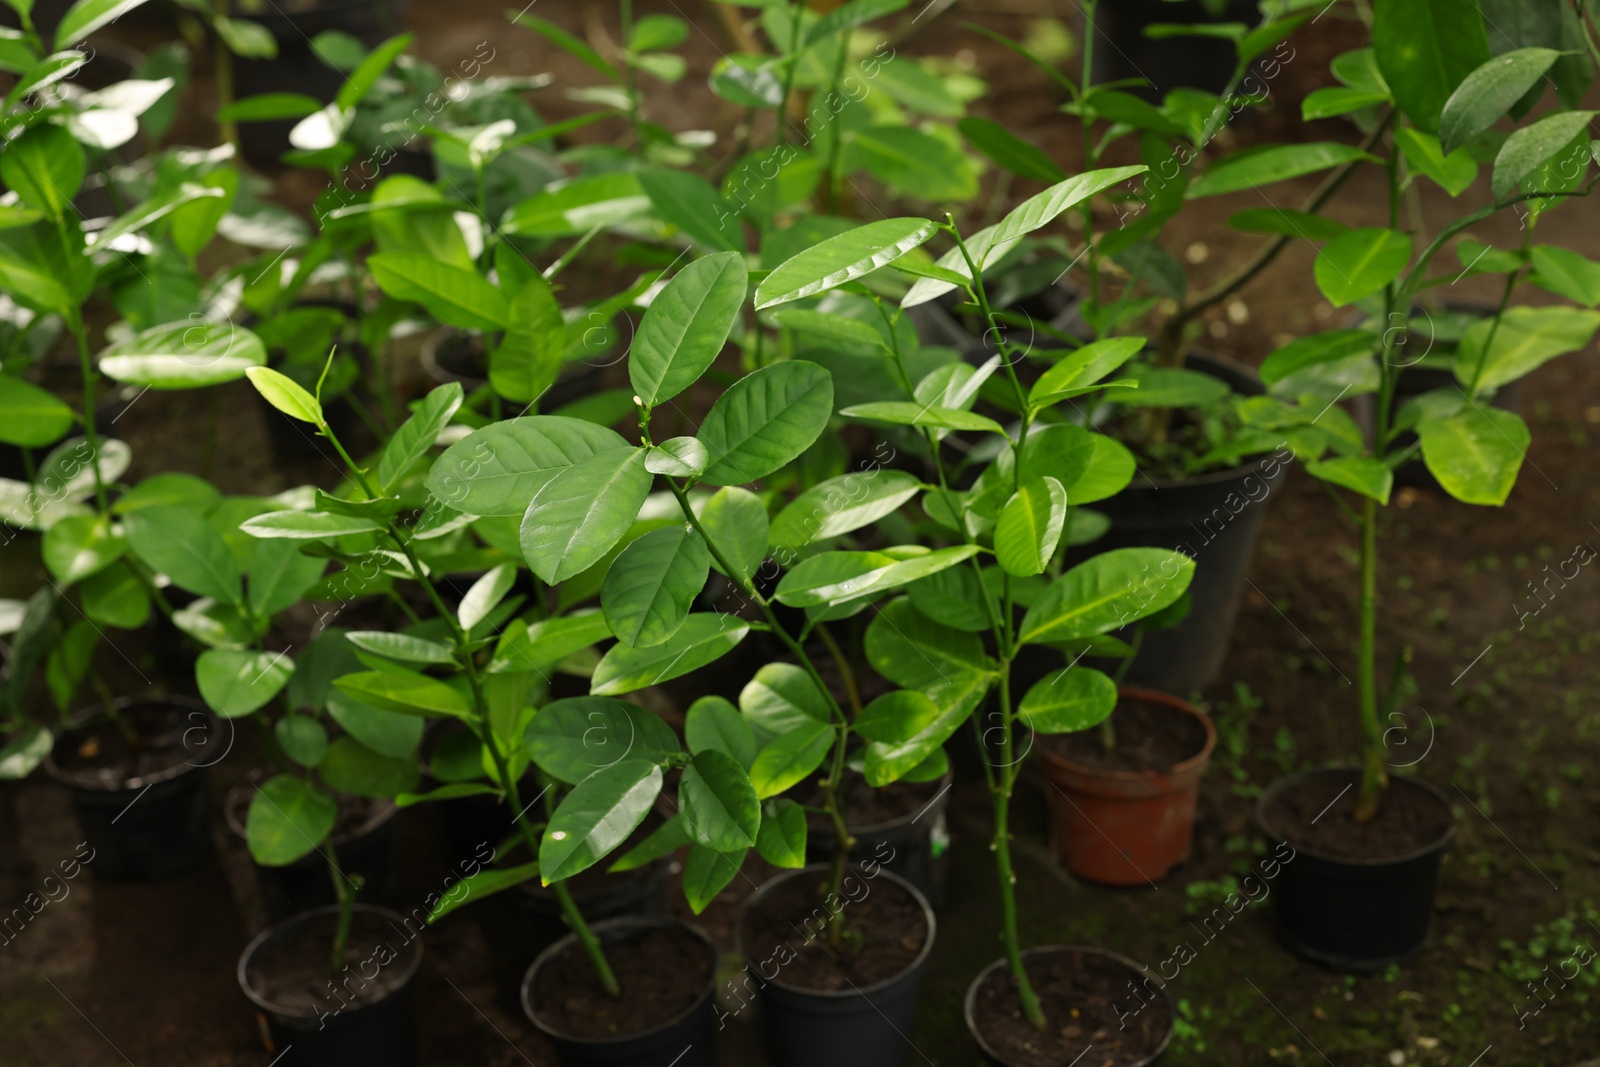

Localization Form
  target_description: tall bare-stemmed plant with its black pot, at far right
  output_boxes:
[1258,0,1600,971]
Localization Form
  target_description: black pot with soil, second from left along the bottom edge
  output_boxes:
[522,918,717,1067]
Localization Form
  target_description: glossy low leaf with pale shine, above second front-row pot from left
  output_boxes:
[539,760,662,885]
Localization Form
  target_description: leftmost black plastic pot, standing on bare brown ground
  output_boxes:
[45,697,220,878]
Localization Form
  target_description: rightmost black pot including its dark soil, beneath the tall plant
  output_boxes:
[1256,769,1454,973]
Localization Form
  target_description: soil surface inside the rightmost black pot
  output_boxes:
[1266,771,1451,859]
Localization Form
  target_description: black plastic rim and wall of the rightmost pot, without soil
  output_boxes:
[1256,768,1456,973]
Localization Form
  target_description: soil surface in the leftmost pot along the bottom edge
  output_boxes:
[245,912,421,1014]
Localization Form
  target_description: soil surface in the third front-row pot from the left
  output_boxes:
[741,867,928,992]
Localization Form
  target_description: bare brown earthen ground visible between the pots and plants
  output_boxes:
[0,0,1600,1067]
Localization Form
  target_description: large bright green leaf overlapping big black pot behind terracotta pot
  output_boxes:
[1018,549,1195,645]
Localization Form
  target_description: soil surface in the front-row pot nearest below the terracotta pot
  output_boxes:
[973,952,1173,1067]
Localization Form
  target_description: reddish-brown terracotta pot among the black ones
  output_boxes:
[1038,688,1216,886]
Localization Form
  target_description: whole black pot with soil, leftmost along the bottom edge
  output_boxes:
[238,904,422,1067]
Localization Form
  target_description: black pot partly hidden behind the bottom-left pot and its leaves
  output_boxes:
[222,769,400,920]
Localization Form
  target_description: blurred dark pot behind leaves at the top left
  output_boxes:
[234,0,406,166]
